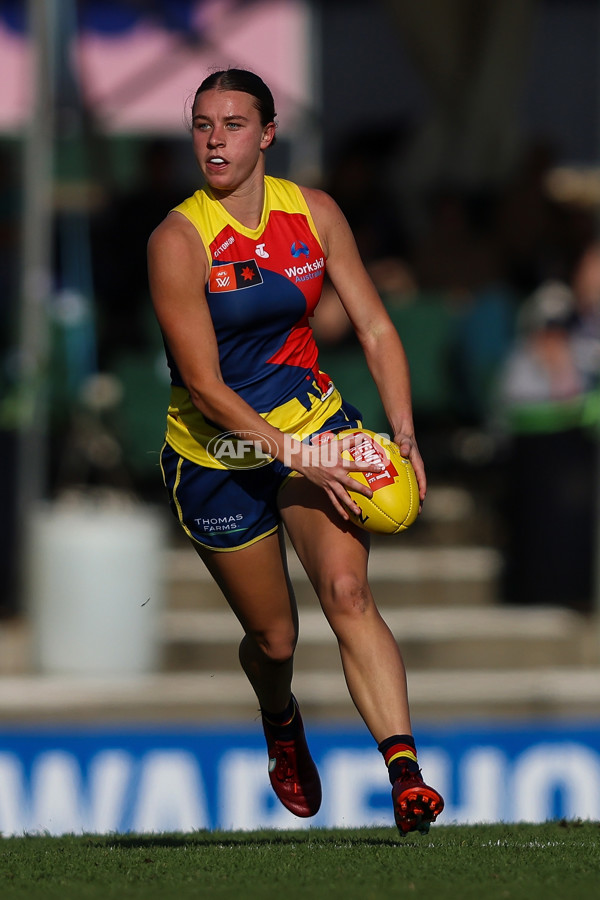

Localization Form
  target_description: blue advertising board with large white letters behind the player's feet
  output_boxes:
[0,722,600,836]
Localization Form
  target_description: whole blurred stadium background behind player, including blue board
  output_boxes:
[0,0,600,833]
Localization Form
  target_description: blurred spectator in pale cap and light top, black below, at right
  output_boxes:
[499,275,598,611]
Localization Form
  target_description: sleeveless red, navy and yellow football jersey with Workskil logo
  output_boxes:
[166,176,352,468]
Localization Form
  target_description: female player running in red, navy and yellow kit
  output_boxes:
[148,69,443,834]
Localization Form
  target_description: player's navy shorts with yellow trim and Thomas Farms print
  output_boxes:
[161,404,360,552]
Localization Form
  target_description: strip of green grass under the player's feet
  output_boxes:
[0,822,600,900]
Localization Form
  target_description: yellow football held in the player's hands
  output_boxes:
[337,428,419,534]
